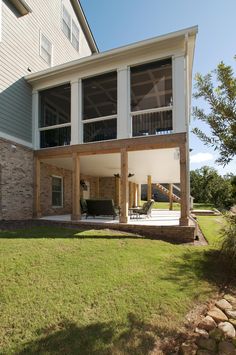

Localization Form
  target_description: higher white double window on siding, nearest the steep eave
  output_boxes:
[62,5,79,52]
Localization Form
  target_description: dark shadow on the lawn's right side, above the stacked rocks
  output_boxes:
[165,249,235,293]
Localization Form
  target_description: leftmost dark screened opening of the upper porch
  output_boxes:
[39,84,71,148]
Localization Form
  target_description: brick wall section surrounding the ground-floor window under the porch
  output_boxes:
[40,163,72,216]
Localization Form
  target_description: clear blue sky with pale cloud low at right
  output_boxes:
[80,0,236,175]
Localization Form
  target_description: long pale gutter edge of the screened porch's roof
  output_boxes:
[25,26,198,82]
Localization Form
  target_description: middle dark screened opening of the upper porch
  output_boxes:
[82,72,117,142]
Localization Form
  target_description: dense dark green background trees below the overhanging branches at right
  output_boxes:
[190,166,236,209]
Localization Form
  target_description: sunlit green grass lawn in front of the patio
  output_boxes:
[0,217,224,355]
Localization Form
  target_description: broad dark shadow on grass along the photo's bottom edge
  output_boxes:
[16,314,179,355]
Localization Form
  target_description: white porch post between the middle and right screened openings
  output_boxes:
[117,67,132,139]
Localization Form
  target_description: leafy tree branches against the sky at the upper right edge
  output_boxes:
[193,57,236,166]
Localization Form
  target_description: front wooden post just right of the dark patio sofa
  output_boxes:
[120,149,129,223]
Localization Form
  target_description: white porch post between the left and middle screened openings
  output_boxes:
[71,80,83,145]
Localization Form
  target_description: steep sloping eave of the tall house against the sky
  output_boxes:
[71,0,99,53]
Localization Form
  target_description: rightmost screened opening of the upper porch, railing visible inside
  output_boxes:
[131,59,173,136]
